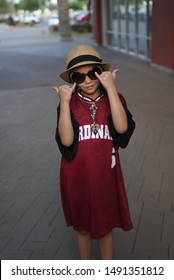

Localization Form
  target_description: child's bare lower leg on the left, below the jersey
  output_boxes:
[77,231,92,260]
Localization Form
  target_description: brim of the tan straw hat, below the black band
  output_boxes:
[60,61,110,84]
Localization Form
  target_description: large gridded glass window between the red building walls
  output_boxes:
[103,0,152,59]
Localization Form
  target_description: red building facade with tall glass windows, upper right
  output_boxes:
[92,0,174,72]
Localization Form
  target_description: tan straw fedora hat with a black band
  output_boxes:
[60,45,110,83]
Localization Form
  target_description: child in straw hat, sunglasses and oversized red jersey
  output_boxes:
[54,45,135,260]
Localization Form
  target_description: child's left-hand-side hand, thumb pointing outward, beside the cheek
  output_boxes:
[53,83,76,103]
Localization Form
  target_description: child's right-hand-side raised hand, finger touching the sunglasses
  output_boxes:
[95,69,118,90]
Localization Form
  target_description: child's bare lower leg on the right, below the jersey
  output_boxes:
[99,231,114,260]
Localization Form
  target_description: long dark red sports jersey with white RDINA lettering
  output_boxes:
[57,91,132,239]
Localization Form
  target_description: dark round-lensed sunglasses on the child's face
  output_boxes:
[70,66,103,85]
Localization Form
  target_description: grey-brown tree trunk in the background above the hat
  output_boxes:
[57,0,72,41]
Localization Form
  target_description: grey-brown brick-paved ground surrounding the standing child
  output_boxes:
[0,25,174,260]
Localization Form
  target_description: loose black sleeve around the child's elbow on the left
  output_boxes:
[55,107,79,161]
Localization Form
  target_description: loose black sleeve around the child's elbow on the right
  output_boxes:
[108,94,136,149]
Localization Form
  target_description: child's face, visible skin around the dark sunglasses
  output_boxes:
[73,65,100,98]
